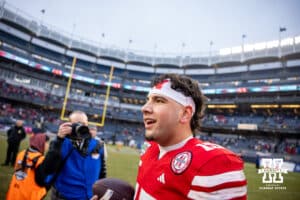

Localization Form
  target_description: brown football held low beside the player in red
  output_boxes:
[93,178,134,200]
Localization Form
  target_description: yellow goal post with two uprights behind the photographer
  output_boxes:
[60,57,114,127]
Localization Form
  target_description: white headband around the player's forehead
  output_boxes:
[148,79,195,114]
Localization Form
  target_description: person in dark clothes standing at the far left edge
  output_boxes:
[2,120,26,166]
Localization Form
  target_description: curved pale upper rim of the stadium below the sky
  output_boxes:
[0,1,300,69]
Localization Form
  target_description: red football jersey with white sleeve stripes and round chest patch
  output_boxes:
[135,138,247,200]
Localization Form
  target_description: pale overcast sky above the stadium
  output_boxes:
[6,0,300,54]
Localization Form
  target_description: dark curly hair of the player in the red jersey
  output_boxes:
[151,74,206,133]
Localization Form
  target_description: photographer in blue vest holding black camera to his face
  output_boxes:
[36,111,106,200]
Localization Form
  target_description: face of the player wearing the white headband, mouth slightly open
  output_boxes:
[142,94,183,146]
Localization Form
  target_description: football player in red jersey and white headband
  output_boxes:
[135,74,247,200]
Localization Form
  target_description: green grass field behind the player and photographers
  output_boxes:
[0,135,300,200]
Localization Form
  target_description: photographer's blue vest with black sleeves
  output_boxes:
[37,138,106,200]
